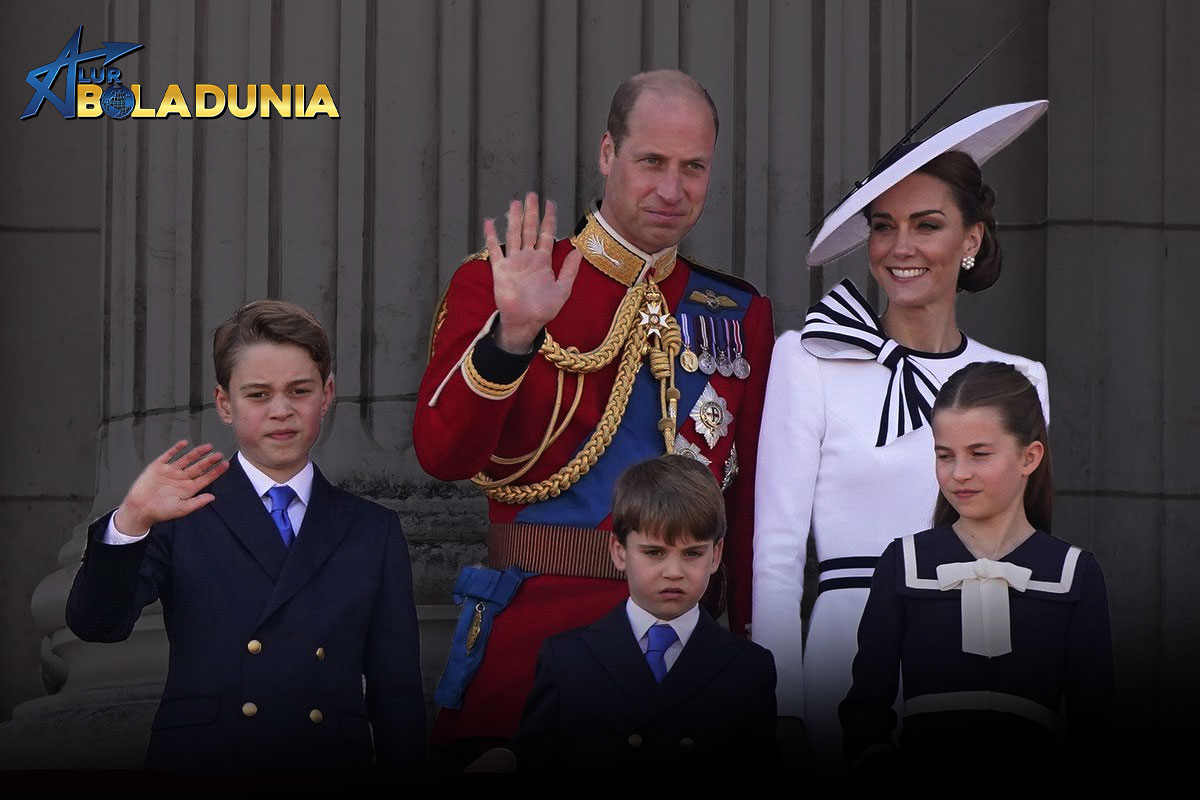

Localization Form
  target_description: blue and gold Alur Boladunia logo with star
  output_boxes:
[20,25,341,120]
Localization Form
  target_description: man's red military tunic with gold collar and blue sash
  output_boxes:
[413,209,774,739]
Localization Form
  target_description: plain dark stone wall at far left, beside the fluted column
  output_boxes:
[0,4,104,768]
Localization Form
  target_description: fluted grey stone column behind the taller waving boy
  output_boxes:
[0,0,484,768]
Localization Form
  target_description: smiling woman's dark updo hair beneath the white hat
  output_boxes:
[863,148,1003,291]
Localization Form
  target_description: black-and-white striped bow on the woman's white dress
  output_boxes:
[800,278,941,447]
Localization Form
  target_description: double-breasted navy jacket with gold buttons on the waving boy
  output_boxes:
[67,459,426,771]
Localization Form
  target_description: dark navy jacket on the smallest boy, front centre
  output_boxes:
[512,602,779,772]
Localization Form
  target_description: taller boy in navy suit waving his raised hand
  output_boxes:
[66,300,426,772]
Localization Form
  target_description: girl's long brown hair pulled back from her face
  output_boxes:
[934,361,1054,533]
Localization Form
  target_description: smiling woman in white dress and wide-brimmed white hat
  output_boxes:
[751,101,1049,770]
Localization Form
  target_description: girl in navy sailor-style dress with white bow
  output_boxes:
[839,362,1112,774]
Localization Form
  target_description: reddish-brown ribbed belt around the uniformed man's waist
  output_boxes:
[487,522,625,581]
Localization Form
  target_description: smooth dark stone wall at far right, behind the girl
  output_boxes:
[1046,0,1200,752]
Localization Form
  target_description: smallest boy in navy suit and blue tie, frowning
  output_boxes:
[512,456,779,771]
